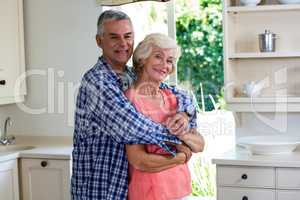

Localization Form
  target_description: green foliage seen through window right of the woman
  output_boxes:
[176,0,224,110]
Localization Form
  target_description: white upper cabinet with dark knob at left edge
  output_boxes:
[0,0,26,104]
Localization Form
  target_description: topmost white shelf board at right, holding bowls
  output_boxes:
[226,4,300,13]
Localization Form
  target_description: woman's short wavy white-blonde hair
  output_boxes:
[132,33,181,74]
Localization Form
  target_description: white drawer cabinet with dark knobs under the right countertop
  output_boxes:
[217,165,300,200]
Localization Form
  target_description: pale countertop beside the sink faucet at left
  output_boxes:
[0,137,73,162]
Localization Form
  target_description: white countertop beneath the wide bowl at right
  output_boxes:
[212,147,300,167]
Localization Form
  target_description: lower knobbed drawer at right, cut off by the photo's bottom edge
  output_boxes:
[217,187,276,200]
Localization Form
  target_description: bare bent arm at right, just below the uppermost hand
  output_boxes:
[177,129,205,153]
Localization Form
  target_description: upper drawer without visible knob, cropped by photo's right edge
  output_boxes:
[276,168,300,189]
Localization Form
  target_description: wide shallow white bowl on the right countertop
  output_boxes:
[237,135,300,155]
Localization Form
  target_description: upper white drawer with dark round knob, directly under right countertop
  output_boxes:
[217,166,275,188]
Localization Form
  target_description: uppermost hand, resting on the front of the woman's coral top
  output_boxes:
[164,112,189,135]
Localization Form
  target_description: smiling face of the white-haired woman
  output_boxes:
[143,47,174,82]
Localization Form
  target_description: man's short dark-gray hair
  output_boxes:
[97,10,131,35]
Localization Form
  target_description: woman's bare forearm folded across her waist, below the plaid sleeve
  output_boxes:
[126,144,186,172]
